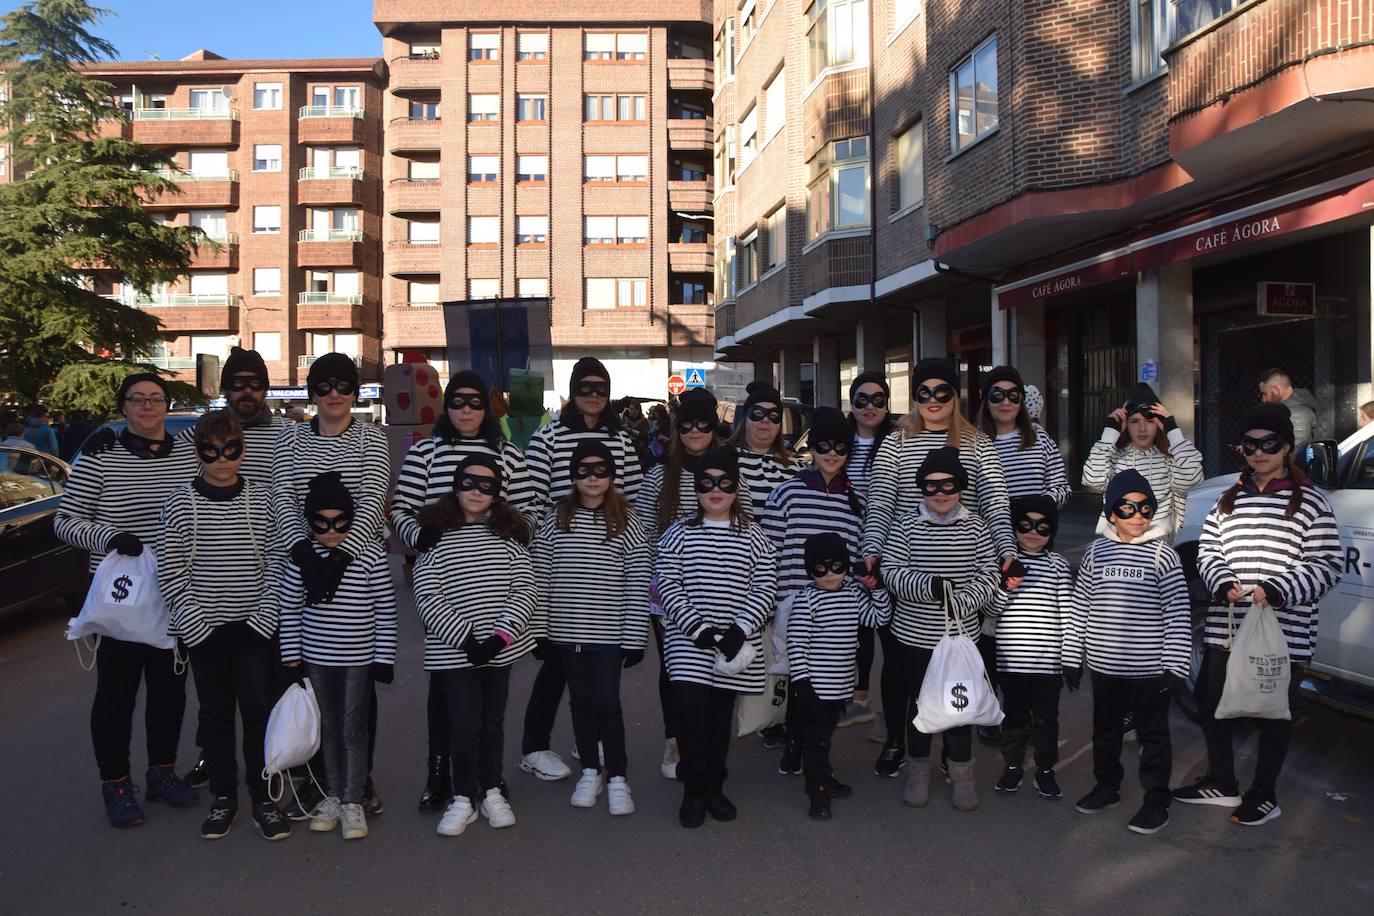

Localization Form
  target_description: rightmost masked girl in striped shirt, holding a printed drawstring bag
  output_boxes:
[1173,404,1342,827]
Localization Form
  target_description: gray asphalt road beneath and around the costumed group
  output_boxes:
[0,538,1374,915]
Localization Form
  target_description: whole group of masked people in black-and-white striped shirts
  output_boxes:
[56,349,1340,839]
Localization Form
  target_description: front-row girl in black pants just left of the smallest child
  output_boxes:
[658,445,778,827]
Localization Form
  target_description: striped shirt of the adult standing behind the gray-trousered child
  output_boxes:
[272,419,392,558]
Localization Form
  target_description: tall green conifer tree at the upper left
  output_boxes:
[0,0,205,402]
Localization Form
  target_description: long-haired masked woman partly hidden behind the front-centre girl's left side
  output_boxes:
[635,389,720,779]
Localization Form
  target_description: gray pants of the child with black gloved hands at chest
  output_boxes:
[305,662,372,805]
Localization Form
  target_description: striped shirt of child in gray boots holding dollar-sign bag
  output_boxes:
[881,504,1000,648]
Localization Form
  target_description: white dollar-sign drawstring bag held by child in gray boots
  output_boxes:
[912,596,1003,735]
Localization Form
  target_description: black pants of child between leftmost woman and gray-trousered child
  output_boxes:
[190,636,278,802]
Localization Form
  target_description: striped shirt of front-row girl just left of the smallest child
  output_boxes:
[658,519,778,694]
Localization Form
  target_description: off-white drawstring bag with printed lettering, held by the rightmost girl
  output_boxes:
[1215,604,1293,718]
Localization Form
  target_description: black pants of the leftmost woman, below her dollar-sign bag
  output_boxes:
[91,636,185,779]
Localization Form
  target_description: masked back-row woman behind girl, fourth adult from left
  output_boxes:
[390,369,537,812]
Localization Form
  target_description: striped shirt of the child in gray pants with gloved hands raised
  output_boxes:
[282,541,396,667]
